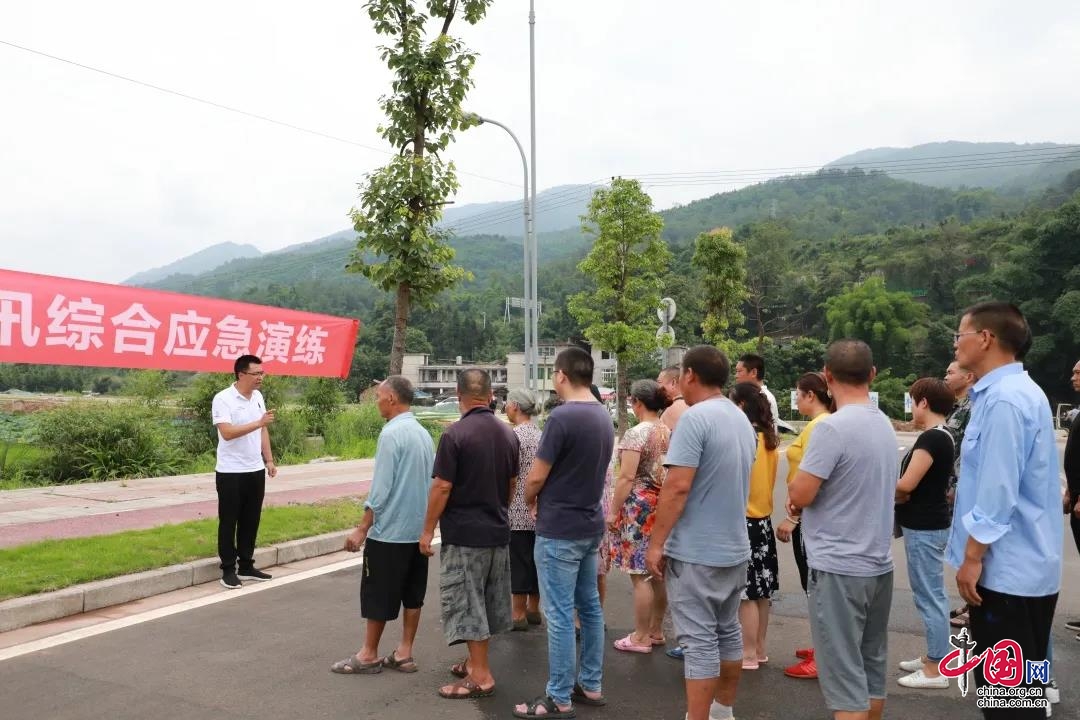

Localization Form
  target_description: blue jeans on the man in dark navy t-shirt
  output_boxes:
[534,534,604,705]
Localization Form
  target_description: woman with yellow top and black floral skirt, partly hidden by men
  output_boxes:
[731,382,780,670]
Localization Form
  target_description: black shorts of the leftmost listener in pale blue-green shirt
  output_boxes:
[360,540,428,622]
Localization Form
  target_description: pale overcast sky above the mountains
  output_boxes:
[0,0,1080,282]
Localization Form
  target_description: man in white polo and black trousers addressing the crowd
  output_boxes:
[212,355,278,589]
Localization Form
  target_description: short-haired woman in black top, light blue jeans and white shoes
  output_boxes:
[896,378,954,689]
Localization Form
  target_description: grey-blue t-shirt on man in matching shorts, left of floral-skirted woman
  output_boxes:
[664,397,757,568]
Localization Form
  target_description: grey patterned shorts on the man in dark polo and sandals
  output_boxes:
[438,545,514,646]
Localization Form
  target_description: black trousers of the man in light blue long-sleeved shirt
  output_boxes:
[969,586,1057,720]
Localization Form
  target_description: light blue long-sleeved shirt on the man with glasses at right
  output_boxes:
[946,363,1064,597]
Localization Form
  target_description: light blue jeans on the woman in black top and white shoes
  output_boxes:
[904,528,951,661]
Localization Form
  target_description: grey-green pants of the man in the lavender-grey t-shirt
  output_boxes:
[807,568,892,712]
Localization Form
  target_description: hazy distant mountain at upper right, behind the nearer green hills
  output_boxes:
[825,141,1080,194]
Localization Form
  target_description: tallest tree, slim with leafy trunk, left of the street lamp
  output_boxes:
[348,0,491,375]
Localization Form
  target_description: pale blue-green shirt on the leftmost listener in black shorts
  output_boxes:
[364,412,435,543]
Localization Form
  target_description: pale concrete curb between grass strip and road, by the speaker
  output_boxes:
[0,530,351,633]
